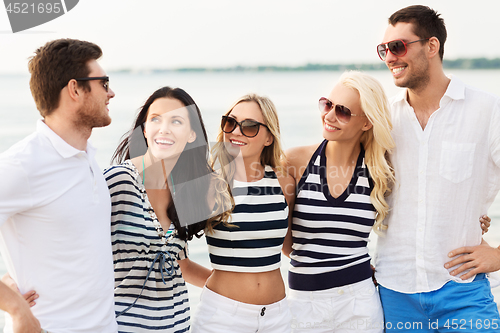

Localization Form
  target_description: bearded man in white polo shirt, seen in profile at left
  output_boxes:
[0,39,117,333]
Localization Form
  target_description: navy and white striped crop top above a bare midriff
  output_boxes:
[205,166,288,273]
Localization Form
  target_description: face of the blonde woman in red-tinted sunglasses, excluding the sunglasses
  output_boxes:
[321,83,372,141]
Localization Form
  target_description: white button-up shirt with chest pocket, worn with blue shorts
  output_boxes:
[376,77,500,293]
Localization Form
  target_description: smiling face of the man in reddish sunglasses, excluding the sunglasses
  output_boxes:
[383,22,430,90]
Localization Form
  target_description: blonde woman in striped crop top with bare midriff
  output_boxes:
[192,94,294,333]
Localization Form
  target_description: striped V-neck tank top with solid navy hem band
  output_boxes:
[288,140,375,291]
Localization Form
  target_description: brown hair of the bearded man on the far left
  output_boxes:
[28,39,102,117]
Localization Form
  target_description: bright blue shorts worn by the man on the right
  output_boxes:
[379,274,500,333]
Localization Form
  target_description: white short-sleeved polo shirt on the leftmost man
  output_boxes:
[0,120,117,333]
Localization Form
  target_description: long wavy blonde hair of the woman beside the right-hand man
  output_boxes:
[339,71,395,235]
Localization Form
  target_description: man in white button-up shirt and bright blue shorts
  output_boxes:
[376,5,500,332]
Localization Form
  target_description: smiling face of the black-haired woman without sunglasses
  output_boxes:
[144,98,196,159]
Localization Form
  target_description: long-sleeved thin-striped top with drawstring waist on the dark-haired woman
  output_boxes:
[104,160,190,332]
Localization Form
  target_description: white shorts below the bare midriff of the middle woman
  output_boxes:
[191,287,292,333]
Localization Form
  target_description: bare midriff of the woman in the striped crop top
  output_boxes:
[207,269,285,305]
